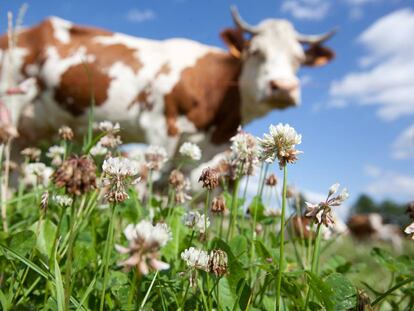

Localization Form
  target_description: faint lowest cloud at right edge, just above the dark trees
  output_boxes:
[365,166,414,199]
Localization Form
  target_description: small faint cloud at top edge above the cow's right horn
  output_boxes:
[281,0,330,20]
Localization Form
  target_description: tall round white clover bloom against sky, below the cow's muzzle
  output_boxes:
[259,123,302,168]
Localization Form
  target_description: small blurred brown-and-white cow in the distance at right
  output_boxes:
[347,213,402,251]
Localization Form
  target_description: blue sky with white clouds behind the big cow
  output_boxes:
[0,0,414,213]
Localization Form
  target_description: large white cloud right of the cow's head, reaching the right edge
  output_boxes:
[330,9,414,120]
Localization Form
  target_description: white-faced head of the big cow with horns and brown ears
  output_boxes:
[221,7,335,110]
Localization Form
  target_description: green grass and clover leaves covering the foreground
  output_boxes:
[0,120,414,310]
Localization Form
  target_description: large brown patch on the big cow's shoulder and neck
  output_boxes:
[165,51,241,144]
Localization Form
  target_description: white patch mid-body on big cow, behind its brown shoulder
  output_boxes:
[94,34,221,156]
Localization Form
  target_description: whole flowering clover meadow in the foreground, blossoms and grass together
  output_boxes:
[0,116,414,310]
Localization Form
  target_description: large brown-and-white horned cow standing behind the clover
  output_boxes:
[0,7,335,183]
